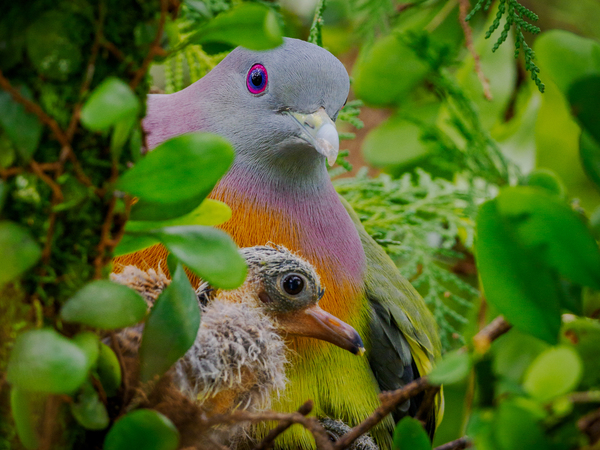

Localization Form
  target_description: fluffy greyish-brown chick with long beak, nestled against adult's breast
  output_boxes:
[112,246,364,446]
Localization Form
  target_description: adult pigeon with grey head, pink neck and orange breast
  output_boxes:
[117,39,441,448]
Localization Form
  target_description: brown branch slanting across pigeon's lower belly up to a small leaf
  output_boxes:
[334,377,431,450]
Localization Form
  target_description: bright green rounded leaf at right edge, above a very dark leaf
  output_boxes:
[535,30,600,95]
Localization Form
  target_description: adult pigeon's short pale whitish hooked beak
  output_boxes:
[288,107,340,166]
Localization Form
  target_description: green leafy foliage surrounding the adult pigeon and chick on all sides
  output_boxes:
[0,0,600,450]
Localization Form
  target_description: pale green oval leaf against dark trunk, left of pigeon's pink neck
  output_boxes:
[81,77,140,131]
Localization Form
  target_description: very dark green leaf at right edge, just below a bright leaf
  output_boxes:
[568,74,600,142]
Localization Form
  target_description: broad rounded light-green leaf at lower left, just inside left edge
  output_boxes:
[7,328,90,394]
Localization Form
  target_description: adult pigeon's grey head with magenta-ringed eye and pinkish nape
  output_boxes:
[144,38,350,179]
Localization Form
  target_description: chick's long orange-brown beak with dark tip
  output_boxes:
[279,305,365,355]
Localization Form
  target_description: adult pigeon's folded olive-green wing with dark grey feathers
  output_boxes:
[340,197,443,423]
